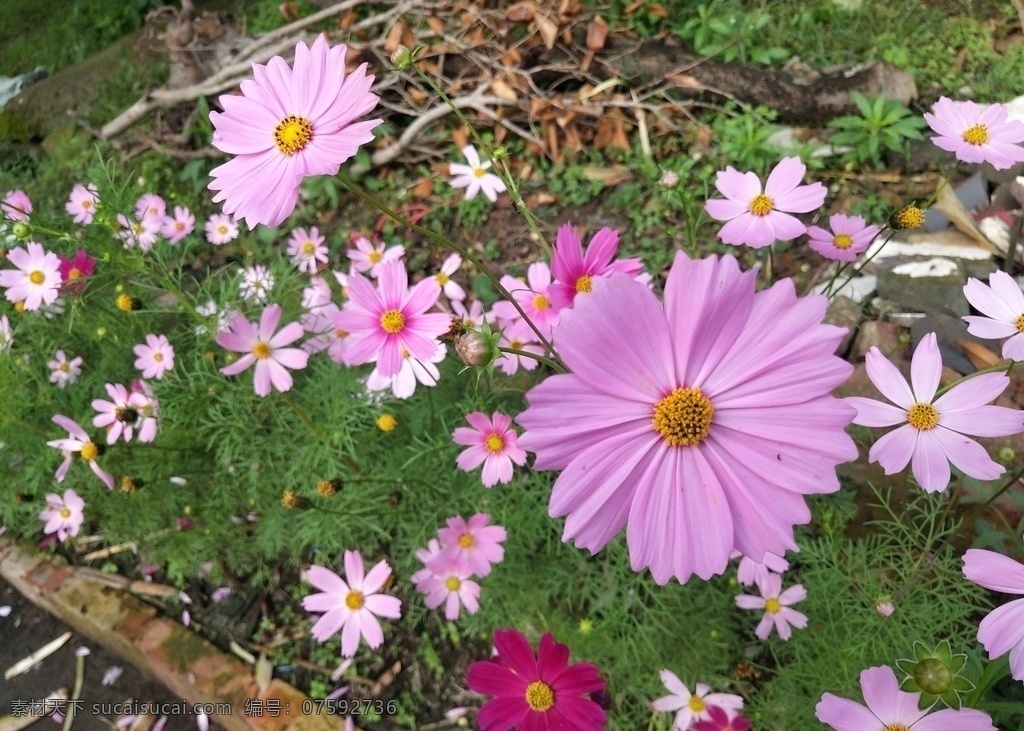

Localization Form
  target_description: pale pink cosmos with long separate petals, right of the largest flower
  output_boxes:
[845,333,1024,492]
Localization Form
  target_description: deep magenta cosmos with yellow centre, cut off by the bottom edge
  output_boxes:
[466,630,605,731]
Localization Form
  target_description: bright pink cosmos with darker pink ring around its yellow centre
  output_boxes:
[335,261,452,377]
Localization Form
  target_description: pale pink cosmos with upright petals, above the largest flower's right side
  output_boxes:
[705,158,828,249]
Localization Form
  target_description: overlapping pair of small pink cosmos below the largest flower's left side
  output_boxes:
[412,513,508,621]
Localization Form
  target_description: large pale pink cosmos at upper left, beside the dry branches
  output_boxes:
[210,35,382,228]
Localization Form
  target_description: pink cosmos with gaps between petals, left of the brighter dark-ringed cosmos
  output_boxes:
[217,305,309,396]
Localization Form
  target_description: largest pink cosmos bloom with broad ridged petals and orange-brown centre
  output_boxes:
[517,252,857,584]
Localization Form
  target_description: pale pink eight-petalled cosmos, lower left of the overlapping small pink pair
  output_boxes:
[302,551,401,657]
